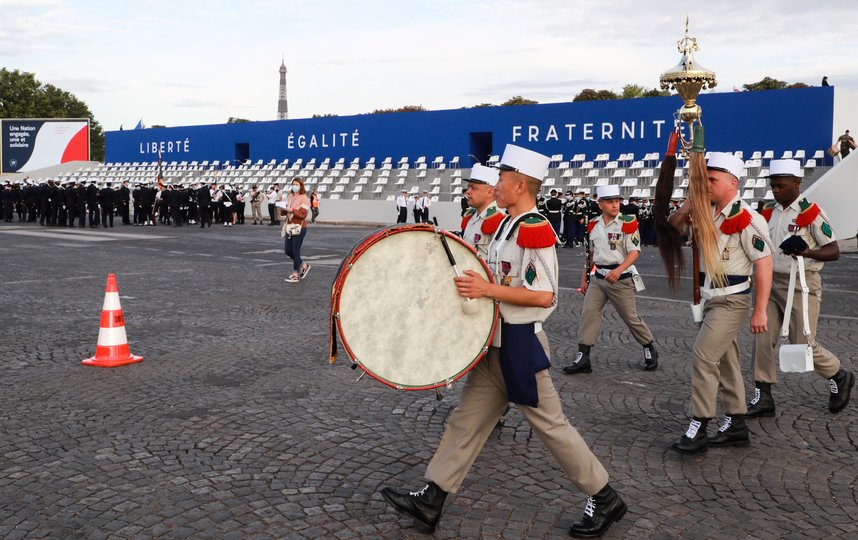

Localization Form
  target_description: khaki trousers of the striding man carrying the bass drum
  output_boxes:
[426,332,608,495]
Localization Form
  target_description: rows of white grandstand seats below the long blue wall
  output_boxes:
[25,146,830,202]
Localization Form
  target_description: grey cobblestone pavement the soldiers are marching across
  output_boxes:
[0,221,858,539]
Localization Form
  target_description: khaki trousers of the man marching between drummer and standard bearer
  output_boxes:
[578,276,652,347]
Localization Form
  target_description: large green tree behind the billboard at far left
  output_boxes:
[0,68,104,161]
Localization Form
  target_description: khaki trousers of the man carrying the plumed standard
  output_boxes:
[691,294,751,418]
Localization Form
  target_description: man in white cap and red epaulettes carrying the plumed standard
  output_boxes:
[668,152,772,454]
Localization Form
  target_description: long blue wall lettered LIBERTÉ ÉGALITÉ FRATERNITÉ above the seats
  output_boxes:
[105,87,834,166]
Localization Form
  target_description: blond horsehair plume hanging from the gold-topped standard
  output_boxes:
[688,122,727,287]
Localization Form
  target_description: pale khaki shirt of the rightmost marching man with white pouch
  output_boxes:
[769,197,837,274]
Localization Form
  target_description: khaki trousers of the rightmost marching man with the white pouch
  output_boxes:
[751,272,840,383]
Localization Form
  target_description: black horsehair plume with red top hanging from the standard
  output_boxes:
[653,130,685,292]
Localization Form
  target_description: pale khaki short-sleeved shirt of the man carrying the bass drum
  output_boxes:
[489,207,559,324]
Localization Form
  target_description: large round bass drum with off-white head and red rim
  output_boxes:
[334,226,497,390]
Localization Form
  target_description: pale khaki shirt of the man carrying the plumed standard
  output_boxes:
[701,194,772,276]
